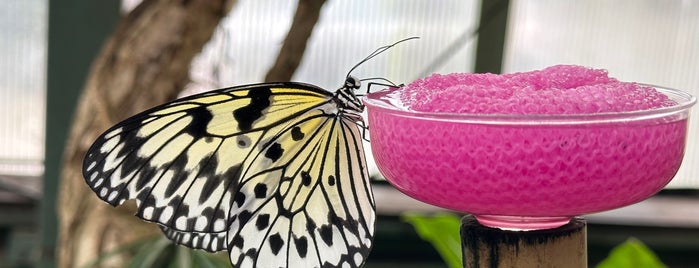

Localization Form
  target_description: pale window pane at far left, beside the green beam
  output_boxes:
[0,0,47,175]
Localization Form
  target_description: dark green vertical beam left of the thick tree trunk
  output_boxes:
[39,0,120,267]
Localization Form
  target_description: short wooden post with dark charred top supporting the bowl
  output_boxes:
[461,215,587,268]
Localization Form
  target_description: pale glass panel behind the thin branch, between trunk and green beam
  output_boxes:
[183,0,479,90]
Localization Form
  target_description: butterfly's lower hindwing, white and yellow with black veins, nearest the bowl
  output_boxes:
[227,110,375,267]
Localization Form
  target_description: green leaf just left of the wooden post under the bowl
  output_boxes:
[402,213,463,268]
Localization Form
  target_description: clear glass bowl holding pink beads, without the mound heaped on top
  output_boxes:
[363,86,696,230]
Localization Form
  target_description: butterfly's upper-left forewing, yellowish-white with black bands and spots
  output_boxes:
[83,83,331,237]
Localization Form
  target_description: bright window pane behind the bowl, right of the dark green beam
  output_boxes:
[504,0,699,188]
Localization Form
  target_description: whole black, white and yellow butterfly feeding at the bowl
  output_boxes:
[83,38,413,267]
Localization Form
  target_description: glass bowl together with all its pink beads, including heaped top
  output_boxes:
[365,66,696,229]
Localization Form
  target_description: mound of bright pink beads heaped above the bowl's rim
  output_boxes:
[401,65,675,114]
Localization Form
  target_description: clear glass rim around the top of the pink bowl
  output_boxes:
[362,83,697,125]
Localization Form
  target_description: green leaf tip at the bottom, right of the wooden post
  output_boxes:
[597,238,666,268]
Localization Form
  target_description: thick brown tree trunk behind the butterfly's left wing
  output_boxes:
[56,0,235,267]
